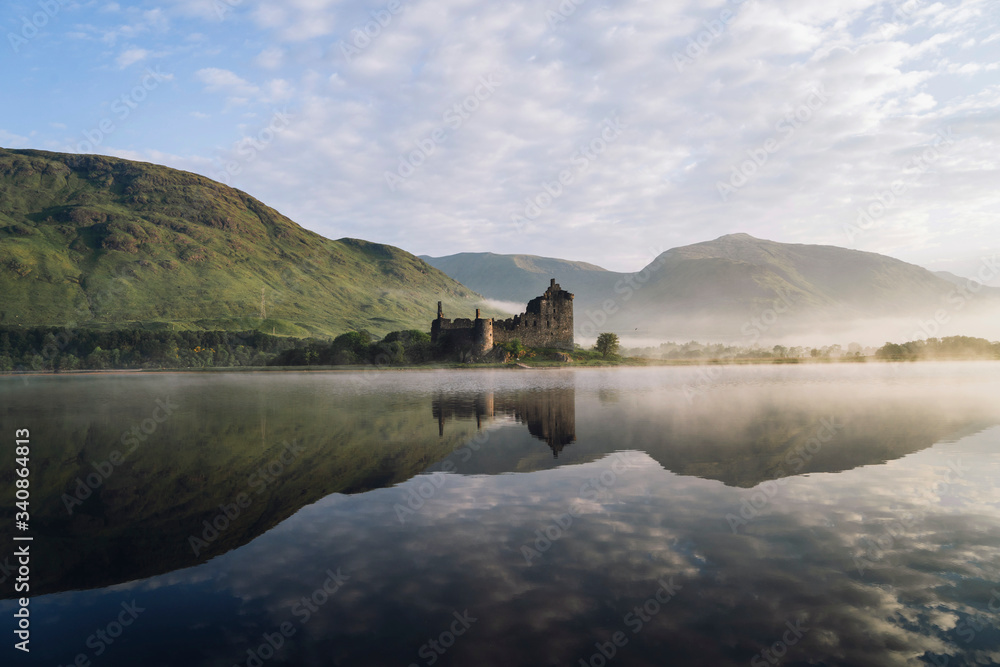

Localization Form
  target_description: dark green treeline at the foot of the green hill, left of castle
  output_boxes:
[0,326,434,372]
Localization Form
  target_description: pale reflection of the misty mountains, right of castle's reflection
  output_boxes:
[442,385,1000,487]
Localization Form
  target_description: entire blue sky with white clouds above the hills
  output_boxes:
[0,0,1000,276]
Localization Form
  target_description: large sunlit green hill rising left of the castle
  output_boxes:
[0,149,492,335]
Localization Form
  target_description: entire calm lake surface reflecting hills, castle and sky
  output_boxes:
[0,363,1000,667]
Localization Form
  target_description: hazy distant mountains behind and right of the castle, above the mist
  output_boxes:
[430,234,1000,344]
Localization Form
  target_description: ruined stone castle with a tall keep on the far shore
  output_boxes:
[431,278,573,356]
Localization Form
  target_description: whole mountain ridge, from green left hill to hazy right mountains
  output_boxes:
[0,148,1000,344]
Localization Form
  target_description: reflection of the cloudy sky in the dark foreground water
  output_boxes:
[21,422,1000,665]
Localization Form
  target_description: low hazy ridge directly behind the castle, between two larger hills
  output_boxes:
[420,252,621,303]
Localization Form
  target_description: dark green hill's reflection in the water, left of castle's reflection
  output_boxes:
[0,376,474,595]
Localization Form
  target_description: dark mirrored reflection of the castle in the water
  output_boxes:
[431,387,576,458]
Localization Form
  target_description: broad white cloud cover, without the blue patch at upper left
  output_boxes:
[66,0,1000,270]
